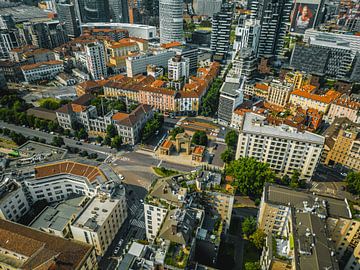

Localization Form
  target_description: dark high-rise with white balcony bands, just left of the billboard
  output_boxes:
[248,0,293,56]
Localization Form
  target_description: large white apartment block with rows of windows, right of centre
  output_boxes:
[236,113,324,180]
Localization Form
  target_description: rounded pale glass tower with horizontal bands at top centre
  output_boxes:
[159,0,184,44]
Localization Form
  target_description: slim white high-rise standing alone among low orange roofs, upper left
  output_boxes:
[85,42,107,80]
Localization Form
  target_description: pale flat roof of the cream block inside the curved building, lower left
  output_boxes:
[73,197,119,231]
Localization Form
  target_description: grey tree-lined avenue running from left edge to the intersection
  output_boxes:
[0,121,116,156]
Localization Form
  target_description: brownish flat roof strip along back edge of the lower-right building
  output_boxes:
[265,184,352,219]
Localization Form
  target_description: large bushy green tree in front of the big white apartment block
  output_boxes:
[225,157,275,198]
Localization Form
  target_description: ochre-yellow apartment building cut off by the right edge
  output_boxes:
[324,121,360,171]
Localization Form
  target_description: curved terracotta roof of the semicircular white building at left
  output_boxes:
[35,161,107,183]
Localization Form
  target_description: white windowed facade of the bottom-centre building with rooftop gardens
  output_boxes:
[144,203,168,241]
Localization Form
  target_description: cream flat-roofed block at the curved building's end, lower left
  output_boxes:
[71,194,127,256]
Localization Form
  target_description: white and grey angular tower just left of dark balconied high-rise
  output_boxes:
[233,15,261,54]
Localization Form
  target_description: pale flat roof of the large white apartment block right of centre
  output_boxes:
[242,113,325,144]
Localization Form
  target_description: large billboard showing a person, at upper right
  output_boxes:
[290,3,319,34]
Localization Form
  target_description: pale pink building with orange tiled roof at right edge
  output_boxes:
[327,97,360,124]
